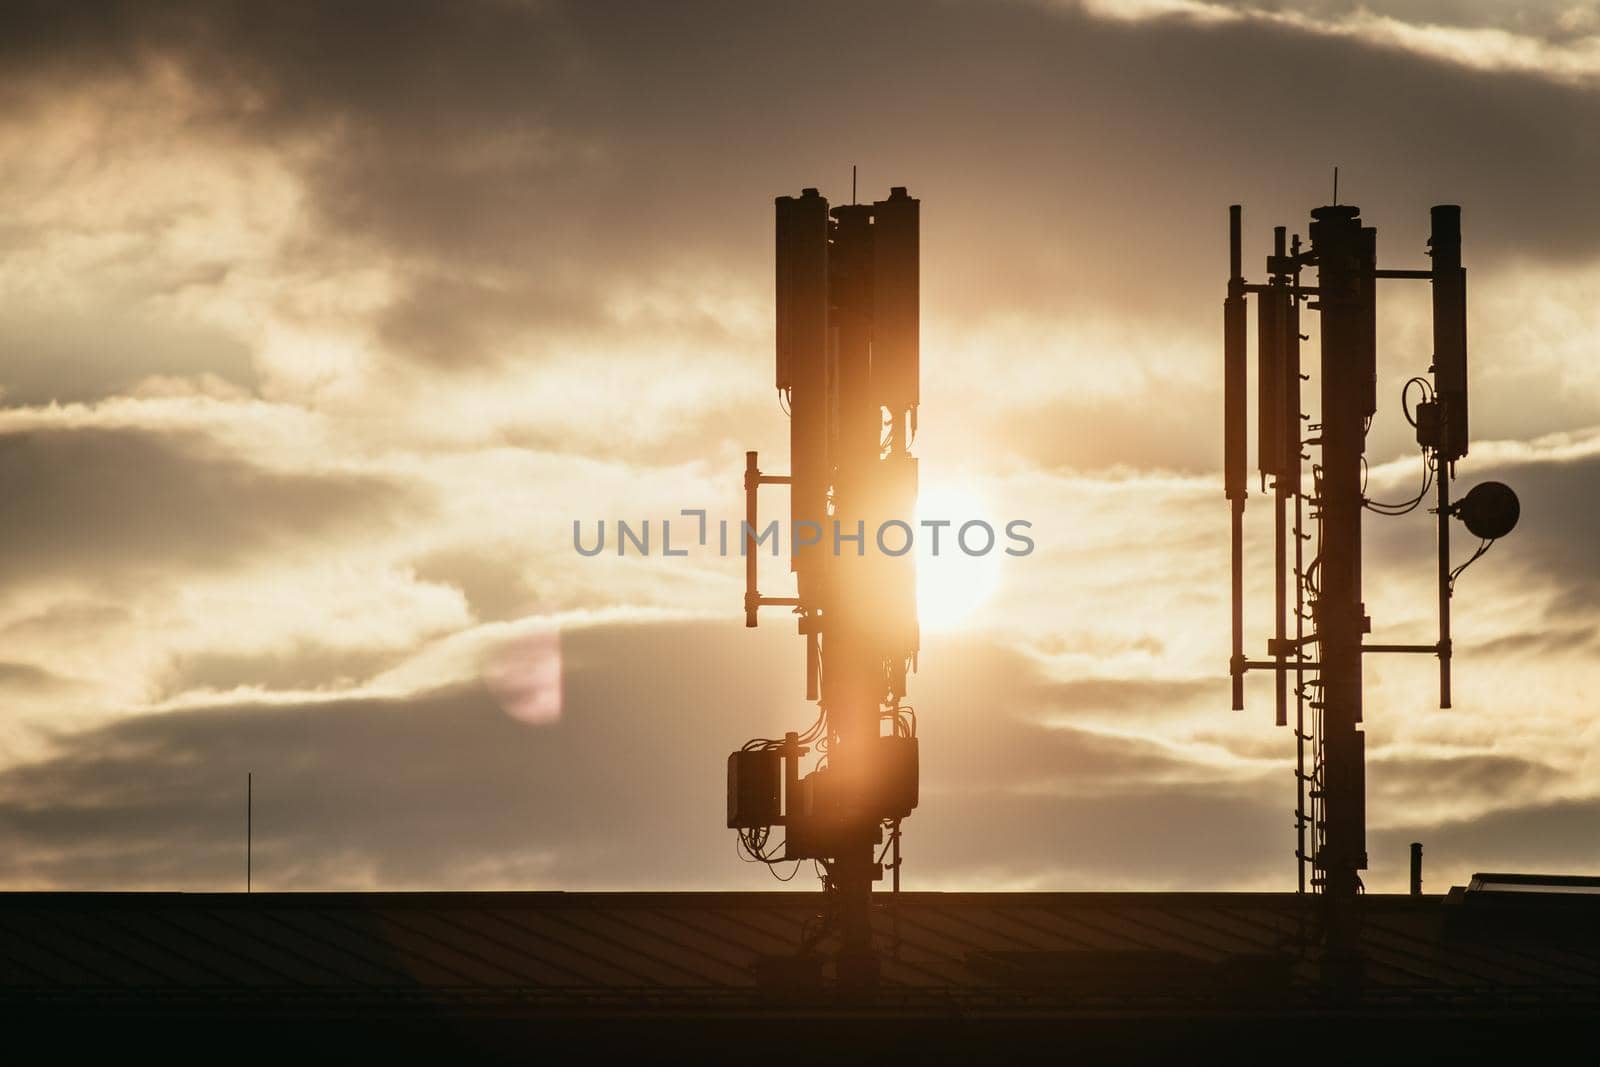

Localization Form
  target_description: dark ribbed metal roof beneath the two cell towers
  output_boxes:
[0,893,1600,1016]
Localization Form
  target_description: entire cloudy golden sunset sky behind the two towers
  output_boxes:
[0,0,1600,891]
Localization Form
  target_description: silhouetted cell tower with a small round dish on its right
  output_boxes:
[1224,203,1518,973]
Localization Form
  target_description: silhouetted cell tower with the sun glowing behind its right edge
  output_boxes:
[728,187,920,984]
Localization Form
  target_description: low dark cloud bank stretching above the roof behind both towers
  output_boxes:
[0,607,1594,889]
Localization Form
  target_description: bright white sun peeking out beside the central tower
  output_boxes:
[917,485,1005,630]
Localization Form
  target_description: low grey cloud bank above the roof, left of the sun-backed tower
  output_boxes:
[0,627,793,888]
